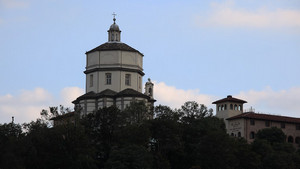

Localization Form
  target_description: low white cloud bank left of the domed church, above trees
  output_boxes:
[0,87,84,123]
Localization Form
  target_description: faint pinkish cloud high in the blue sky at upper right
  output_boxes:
[196,1,300,29]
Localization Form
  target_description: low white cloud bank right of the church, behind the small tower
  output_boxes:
[154,82,300,117]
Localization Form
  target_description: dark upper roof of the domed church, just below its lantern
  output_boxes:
[85,42,144,56]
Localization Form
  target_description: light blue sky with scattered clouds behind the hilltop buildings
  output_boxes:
[0,0,300,123]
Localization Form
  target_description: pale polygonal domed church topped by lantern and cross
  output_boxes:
[72,17,156,115]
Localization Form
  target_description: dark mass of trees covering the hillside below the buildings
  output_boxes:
[0,102,300,169]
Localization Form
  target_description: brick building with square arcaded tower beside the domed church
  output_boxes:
[213,96,300,145]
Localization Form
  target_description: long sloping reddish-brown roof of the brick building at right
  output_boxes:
[227,112,300,123]
